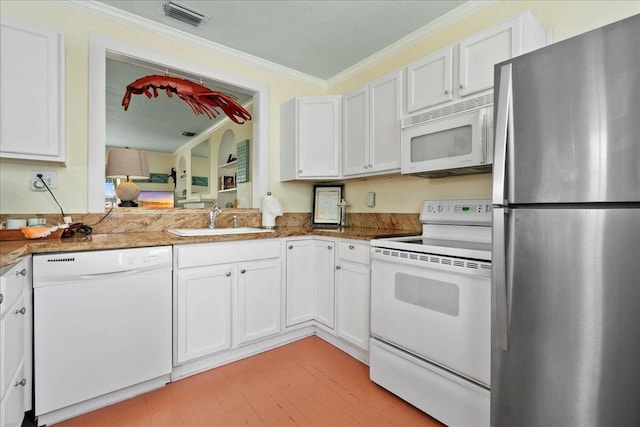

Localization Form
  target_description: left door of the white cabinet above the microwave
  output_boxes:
[407,46,453,113]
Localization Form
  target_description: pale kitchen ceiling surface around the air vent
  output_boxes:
[100,0,465,80]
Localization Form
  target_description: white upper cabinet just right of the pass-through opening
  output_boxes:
[280,96,342,181]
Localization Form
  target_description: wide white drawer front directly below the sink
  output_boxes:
[176,239,280,268]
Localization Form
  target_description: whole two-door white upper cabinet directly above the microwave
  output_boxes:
[405,12,545,115]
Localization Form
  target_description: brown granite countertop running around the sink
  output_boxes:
[0,227,416,267]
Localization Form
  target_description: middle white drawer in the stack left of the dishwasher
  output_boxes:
[0,297,25,402]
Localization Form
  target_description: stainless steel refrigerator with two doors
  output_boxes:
[491,15,640,427]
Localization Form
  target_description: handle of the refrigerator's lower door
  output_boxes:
[491,207,509,351]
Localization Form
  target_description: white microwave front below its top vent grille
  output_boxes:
[401,108,492,174]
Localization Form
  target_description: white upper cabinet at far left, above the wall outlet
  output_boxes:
[0,16,66,164]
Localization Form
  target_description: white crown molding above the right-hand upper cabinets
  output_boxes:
[327,0,498,87]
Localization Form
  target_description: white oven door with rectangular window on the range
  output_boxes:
[371,247,491,387]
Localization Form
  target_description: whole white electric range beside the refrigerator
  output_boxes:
[370,199,491,426]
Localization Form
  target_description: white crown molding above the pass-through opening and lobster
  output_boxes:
[54,0,327,89]
